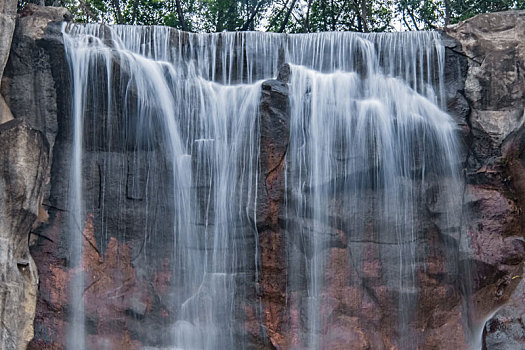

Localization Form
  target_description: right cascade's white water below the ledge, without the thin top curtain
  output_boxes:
[287,66,459,349]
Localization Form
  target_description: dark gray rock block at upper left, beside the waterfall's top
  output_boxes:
[0,4,70,163]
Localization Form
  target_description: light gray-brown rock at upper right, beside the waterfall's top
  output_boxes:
[446,11,525,162]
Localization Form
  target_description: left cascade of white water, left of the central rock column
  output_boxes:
[64,25,266,349]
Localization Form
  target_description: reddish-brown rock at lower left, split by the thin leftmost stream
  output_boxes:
[29,215,151,349]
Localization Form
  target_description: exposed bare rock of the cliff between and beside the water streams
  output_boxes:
[0,6,525,349]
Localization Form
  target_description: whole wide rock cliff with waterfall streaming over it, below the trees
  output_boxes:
[0,5,525,349]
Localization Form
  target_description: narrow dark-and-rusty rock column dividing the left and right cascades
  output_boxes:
[254,65,290,347]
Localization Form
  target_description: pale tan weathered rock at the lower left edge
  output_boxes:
[0,120,48,350]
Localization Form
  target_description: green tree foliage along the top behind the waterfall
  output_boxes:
[18,0,525,33]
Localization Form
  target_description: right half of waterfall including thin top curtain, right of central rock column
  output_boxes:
[287,33,461,349]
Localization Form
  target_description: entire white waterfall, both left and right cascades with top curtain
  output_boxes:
[63,25,460,349]
